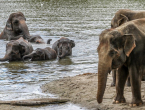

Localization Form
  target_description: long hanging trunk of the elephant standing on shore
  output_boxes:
[97,58,112,103]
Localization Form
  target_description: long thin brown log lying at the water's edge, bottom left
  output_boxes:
[0,98,69,106]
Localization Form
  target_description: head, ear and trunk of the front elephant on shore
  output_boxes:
[97,29,136,103]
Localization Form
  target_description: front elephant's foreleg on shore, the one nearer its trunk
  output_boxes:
[113,66,128,104]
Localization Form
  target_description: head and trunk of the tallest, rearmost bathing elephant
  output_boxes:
[5,12,30,40]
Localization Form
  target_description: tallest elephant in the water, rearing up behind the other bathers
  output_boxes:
[0,12,30,40]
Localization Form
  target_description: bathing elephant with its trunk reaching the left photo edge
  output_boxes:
[0,37,33,61]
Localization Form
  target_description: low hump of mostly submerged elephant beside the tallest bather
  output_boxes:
[28,35,45,44]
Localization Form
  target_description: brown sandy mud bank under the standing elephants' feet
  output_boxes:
[41,73,145,110]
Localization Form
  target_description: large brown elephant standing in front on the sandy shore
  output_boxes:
[97,18,145,106]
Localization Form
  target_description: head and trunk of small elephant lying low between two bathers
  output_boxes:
[23,48,45,61]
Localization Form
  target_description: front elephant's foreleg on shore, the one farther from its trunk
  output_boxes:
[129,64,143,106]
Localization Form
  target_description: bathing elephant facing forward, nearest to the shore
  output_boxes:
[52,37,75,59]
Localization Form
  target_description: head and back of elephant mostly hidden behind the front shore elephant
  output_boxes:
[111,9,145,28]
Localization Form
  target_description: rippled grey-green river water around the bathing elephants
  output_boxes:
[0,0,144,110]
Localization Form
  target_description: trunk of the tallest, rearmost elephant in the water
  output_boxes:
[20,20,30,39]
